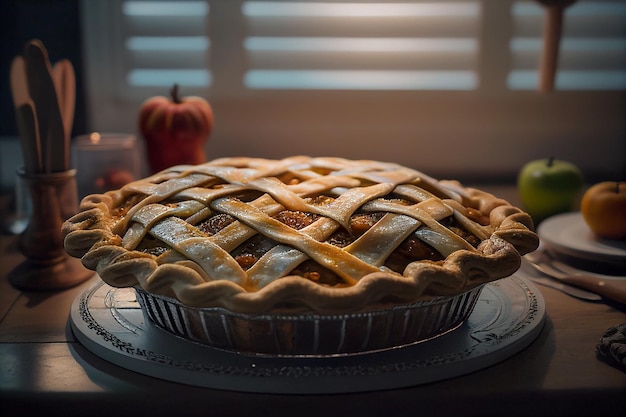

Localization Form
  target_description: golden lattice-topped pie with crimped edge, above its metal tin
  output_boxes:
[63,156,538,313]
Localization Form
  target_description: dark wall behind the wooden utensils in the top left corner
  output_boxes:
[0,0,86,137]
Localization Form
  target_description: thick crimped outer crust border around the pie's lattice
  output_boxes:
[63,159,538,314]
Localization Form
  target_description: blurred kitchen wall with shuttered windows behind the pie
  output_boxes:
[0,0,626,193]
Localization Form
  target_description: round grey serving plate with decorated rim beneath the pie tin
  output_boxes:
[69,272,545,394]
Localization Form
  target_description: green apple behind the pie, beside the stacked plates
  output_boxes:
[517,158,584,224]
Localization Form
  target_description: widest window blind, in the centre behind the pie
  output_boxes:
[242,1,481,90]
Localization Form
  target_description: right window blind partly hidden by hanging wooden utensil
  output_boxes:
[507,0,626,90]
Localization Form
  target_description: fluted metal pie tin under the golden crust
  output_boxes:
[135,285,483,356]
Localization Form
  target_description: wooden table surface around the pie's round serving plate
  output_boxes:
[0,185,626,417]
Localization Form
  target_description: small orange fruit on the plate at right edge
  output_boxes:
[580,181,626,240]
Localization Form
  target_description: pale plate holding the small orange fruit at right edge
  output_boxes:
[537,212,626,264]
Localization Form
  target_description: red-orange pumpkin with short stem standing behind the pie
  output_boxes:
[138,84,213,172]
